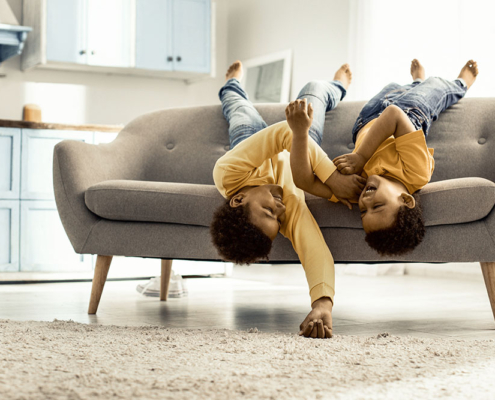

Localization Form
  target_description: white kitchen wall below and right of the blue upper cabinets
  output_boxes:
[0,0,228,124]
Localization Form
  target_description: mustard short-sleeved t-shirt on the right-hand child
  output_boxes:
[331,118,435,202]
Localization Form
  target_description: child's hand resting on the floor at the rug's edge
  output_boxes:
[299,297,333,339]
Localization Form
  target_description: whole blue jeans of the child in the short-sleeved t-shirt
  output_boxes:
[352,77,467,143]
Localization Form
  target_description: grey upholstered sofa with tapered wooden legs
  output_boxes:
[53,98,495,316]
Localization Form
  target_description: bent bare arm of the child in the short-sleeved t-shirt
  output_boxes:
[333,105,416,174]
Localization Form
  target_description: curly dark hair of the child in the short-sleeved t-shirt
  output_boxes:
[366,193,425,256]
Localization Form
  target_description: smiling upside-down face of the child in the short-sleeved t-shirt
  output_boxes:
[358,175,415,233]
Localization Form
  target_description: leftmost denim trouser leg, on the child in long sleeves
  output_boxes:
[218,78,267,149]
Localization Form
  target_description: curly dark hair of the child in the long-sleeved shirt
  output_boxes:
[210,199,272,264]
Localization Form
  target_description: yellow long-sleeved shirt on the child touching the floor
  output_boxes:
[213,121,336,303]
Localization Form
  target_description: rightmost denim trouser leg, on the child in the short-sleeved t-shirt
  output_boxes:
[394,77,467,136]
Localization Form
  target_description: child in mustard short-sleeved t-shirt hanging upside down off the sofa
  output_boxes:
[333,59,478,255]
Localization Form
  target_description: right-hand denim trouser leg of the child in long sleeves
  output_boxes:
[297,80,347,145]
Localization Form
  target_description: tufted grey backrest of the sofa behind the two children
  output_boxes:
[119,98,495,185]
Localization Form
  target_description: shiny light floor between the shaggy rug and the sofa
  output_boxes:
[0,265,495,339]
